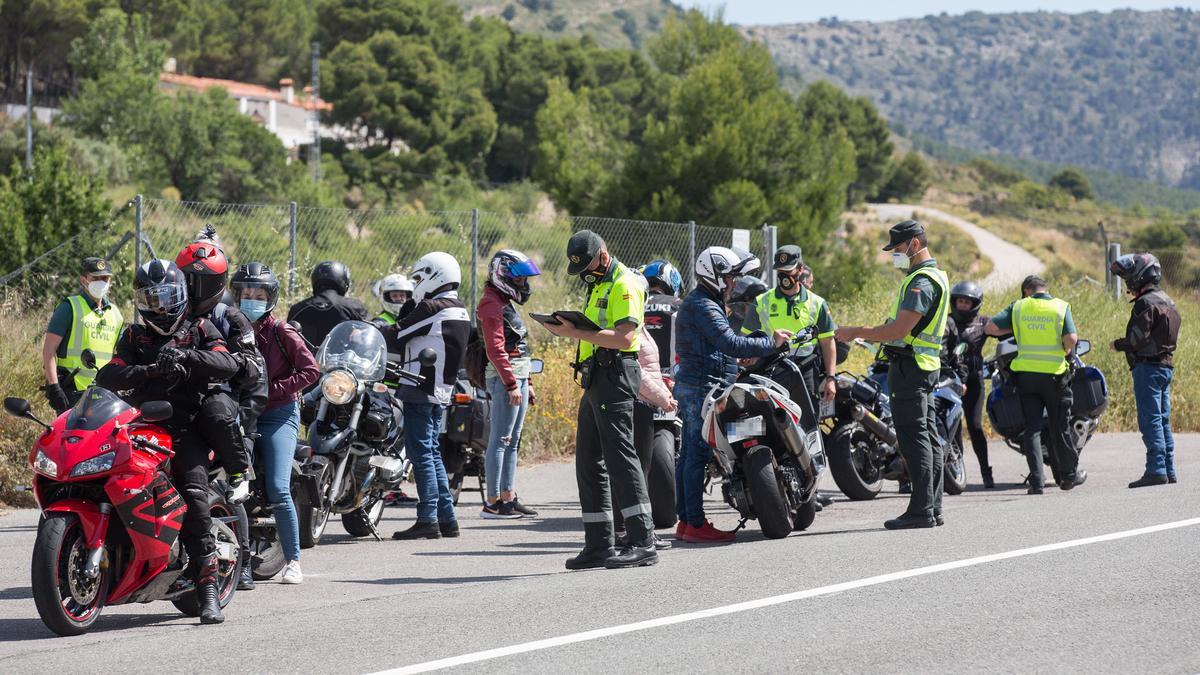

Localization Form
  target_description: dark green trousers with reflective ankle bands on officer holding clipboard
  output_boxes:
[575,354,654,549]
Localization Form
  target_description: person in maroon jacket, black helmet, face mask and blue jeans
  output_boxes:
[230,263,320,584]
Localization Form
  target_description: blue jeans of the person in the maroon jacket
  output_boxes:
[254,404,300,560]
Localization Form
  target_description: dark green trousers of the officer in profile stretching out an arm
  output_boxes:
[888,356,946,518]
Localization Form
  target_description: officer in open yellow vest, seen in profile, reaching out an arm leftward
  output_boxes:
[836,220,950,530]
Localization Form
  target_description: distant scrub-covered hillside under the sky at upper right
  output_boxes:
[744,10,1200,187]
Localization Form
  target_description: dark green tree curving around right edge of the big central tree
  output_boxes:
[799,80,895,205]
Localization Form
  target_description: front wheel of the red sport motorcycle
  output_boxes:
[30,513,110,635]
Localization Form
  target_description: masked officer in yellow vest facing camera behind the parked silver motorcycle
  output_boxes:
[742,244,838,401]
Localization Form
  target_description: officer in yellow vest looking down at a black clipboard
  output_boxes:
[545,229,659,569]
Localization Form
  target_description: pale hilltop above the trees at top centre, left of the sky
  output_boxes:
[455,0,679,49]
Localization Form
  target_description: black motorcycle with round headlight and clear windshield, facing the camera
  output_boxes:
[294,321,437,548]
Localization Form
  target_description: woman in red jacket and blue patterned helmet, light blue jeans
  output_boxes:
[475,250,541,520]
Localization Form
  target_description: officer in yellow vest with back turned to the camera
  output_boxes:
[985,275,1087,495]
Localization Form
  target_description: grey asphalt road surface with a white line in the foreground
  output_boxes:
[0,435,1200,674]
